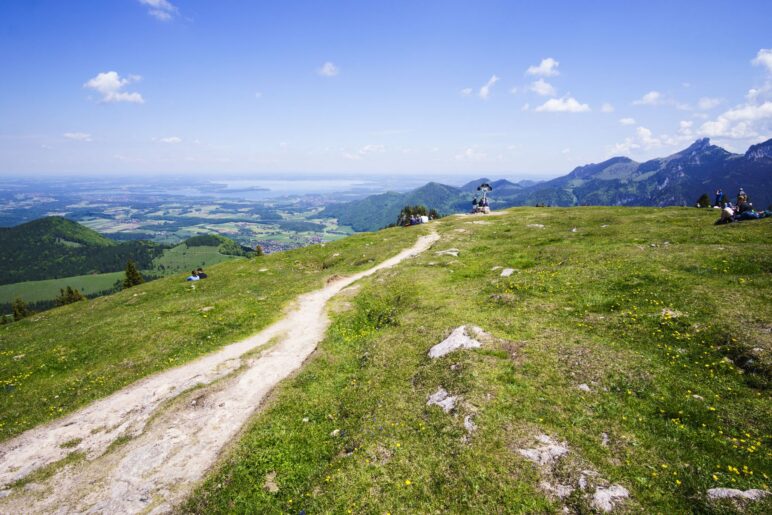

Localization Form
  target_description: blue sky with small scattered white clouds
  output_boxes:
[0,0,772,178]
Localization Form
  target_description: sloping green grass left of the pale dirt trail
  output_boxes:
[0,230,428,440]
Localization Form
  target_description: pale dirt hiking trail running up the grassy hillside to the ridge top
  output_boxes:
[0,233,439,515]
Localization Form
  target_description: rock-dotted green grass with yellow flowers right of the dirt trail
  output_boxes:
[183,208,772,513]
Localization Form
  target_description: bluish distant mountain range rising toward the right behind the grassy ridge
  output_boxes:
[323,138,772,231]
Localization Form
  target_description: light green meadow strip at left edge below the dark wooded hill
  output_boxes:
[0,272,124,304]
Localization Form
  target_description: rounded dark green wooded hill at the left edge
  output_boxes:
[0,217,165,284]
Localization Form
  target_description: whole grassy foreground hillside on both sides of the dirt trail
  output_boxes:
[0,207,772,513]
